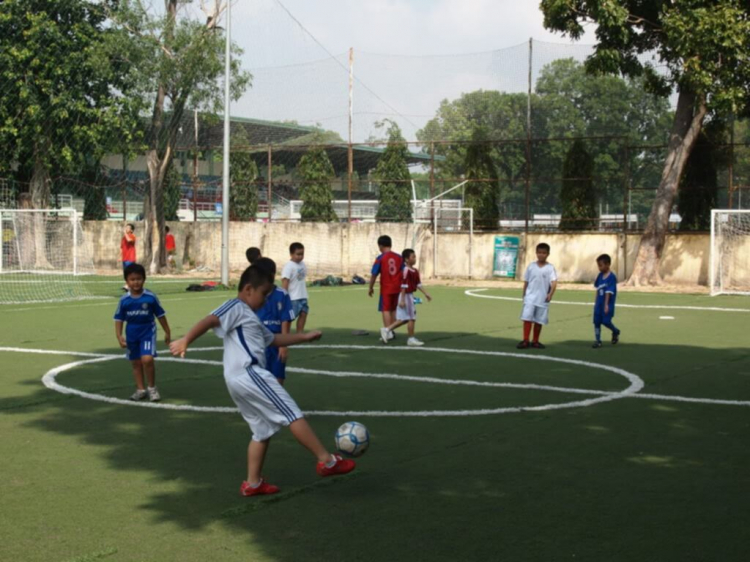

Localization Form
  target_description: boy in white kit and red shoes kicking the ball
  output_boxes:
[169,266,355,496]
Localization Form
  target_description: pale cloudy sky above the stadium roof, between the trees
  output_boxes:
[223,0,593,141]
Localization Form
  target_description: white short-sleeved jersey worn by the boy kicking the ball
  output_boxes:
[211,299,275,378]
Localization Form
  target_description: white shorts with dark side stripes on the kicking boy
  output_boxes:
[224,365,304,441]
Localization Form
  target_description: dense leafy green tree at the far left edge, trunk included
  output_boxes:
[0,0,140,267]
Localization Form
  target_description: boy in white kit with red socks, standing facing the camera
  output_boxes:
[516,242,557,349]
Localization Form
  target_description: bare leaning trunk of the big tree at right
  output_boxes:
[627,91,707,287]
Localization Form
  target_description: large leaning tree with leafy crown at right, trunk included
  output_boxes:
[541,0,750,285]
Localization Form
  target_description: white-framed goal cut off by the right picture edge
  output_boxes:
[710,210,750,295]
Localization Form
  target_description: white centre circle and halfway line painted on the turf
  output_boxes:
[0,345,750,417]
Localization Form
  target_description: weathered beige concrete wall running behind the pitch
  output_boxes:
[84,221,710,285]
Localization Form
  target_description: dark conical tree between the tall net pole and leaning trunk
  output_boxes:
[560,139,596,230]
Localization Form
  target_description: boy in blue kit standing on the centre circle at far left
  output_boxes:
[115,263,171,402]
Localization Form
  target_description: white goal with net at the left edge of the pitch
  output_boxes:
[0,209,94,304]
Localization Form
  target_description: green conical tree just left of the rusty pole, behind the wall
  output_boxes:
[299,144,338,222]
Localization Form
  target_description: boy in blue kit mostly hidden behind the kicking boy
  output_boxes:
[252,257,295,386]
